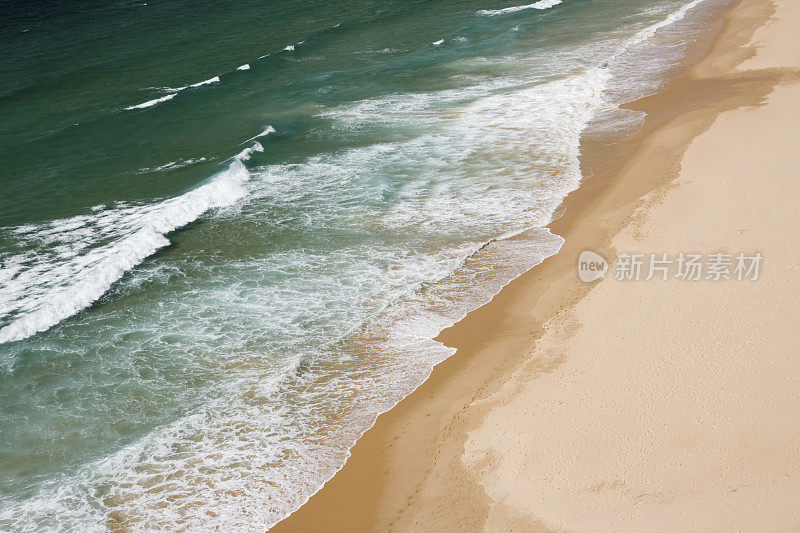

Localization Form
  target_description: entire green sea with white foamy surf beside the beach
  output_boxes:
[0,0,719,531]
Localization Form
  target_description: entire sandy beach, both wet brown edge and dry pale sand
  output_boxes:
[273,0,800,531]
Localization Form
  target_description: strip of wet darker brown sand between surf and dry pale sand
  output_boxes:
[273,0,786,531]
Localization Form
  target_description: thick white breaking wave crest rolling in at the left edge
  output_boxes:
[0,143,263,344]
